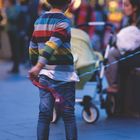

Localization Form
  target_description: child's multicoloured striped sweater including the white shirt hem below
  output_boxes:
[29,12,79,82]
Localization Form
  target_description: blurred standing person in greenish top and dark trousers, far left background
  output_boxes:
[6,0,20,73]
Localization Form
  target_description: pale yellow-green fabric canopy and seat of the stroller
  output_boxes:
[71,28,98,89]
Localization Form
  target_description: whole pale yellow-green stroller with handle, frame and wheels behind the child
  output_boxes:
[52,22,116,123]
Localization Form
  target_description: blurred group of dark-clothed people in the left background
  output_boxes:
[1,0,38,73]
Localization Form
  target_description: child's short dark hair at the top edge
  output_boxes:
[46,0,71,8]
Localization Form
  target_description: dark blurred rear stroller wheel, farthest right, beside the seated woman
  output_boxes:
[105,94,116,117]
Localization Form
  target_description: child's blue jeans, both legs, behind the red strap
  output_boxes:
[37,75,77,140]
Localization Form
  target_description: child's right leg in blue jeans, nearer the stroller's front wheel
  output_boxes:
[57,82,77,140]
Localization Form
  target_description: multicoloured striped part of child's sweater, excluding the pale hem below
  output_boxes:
[29,12,73,65]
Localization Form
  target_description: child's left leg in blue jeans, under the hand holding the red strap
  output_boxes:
[37,75,54,140]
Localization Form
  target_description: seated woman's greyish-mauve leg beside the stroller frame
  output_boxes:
[106,47,121,86]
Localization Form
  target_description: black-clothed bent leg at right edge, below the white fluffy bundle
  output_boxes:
[119,52,140,113]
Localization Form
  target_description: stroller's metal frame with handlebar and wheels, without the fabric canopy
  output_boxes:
[52,22,116,124]
